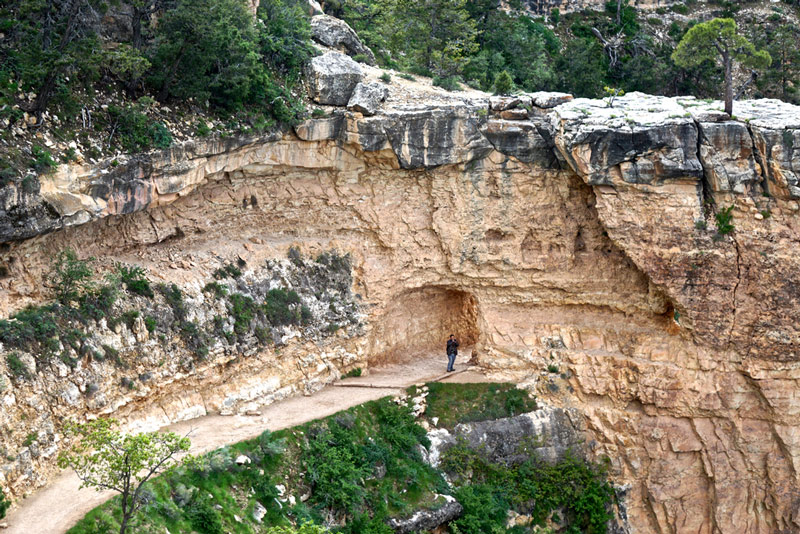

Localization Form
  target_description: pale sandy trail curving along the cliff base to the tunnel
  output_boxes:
[1,351,487,534]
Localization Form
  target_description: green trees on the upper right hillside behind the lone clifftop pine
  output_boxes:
[325,0,800,102]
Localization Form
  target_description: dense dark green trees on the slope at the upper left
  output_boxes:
[0,0,314,165]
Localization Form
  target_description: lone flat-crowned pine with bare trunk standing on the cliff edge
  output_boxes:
[672,19,772,115]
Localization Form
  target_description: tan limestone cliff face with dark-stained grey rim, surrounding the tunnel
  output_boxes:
[0,80,800,533]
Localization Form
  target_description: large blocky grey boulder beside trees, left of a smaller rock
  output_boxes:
[306,52,364,106]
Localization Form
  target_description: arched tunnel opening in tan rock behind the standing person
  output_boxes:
[369,287,480,366]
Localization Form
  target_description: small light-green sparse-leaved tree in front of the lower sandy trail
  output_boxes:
[58,419,190,534]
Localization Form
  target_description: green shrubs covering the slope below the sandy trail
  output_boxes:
[69,384,613,534]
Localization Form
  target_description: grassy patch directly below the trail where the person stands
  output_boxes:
[418,382,536,428]
